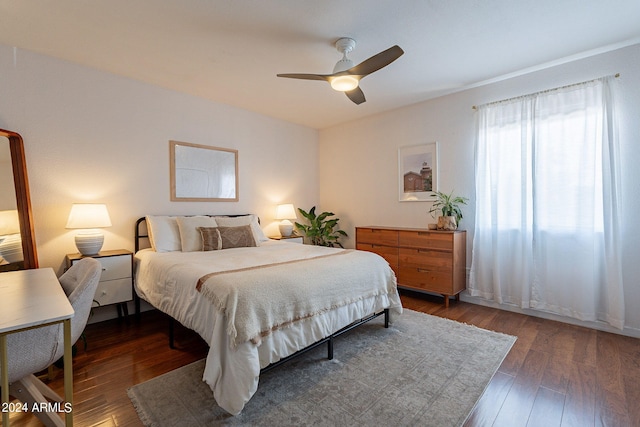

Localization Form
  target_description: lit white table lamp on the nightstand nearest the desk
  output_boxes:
[66,203,111,255]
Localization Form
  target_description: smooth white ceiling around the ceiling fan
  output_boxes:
[0,0,640,129]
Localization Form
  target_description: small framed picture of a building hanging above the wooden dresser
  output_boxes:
[398,142,438,202]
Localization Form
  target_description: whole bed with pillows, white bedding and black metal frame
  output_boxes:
[134,215,402,415]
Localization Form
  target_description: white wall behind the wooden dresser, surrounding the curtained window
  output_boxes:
[319,45,640,335]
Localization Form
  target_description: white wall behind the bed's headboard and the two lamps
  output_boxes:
[0,46,319,273]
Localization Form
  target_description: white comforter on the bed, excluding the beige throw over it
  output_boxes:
[135,241,402,415]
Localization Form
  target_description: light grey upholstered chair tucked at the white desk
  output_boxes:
[7,258,102,427]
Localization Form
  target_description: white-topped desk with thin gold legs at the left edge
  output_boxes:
[0,268,74,427]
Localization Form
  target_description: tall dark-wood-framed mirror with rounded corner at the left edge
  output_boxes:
[0,129,38,272]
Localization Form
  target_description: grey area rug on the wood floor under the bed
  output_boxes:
[127,309,516,427]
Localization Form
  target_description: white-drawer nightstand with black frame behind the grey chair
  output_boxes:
[66,249,133,317]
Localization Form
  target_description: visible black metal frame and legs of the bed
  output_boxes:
[134,214,389,374]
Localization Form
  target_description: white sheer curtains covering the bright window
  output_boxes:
[469,77,624,329]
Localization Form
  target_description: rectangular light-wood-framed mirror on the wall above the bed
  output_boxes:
[169,141,238,202]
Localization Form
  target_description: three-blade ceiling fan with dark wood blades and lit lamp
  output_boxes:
[277,37,404,104]
